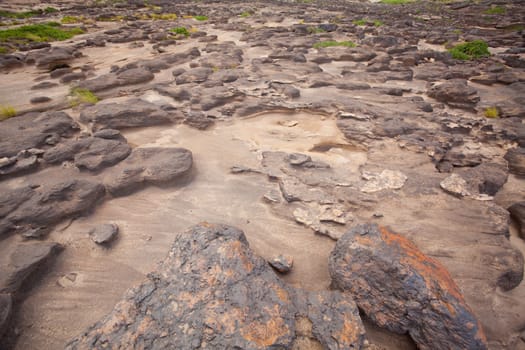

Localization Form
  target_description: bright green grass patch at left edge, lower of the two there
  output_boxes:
[0,22,84,42]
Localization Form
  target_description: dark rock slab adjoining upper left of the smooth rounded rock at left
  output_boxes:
[43,137,131,171]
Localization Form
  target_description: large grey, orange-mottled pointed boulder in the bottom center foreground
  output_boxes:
[66,223,364,350]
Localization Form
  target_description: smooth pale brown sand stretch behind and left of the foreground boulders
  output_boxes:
[11,112,367,349]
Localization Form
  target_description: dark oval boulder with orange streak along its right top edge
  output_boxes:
[329,224,487,350]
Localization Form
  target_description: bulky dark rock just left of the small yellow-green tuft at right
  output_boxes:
[427,79,480,109]
